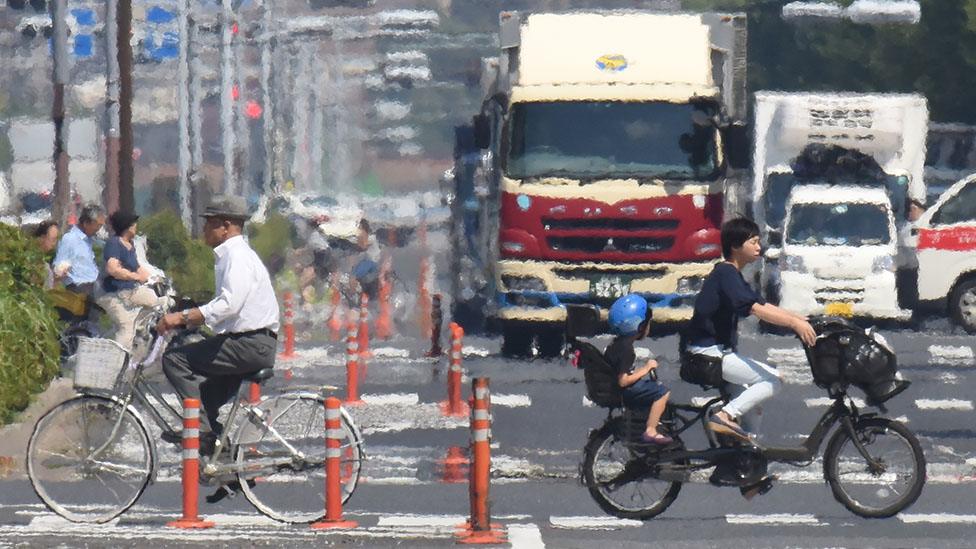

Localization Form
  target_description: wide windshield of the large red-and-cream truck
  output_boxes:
[505,101,718,179]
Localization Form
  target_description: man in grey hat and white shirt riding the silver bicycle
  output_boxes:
[156,196,278,455]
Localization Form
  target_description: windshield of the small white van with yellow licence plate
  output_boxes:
[786,203,891,246]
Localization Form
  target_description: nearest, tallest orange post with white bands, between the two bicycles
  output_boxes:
[457,377,505,544]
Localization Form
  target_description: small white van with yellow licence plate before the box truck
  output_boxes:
[766,184,911,321]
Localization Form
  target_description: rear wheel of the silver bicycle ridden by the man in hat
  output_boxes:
[235,393,365,523]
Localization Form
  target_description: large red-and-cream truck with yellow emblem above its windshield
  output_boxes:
[451,11,748,356]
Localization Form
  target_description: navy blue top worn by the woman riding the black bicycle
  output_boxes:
[685,261,766,350]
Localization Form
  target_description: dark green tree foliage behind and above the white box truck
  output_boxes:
[682,0,976,124]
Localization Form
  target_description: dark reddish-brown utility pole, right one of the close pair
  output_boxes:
[116,0,135,212]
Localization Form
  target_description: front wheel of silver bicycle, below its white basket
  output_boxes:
[27,395,155,522]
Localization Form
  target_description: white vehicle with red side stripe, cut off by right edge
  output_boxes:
[912,174,976,333]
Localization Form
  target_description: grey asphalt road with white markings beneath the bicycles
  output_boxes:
[0,312,976,548]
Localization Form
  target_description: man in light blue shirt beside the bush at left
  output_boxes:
[54,204,105,295]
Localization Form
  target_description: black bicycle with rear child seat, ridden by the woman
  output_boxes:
[567,306,925,520]
